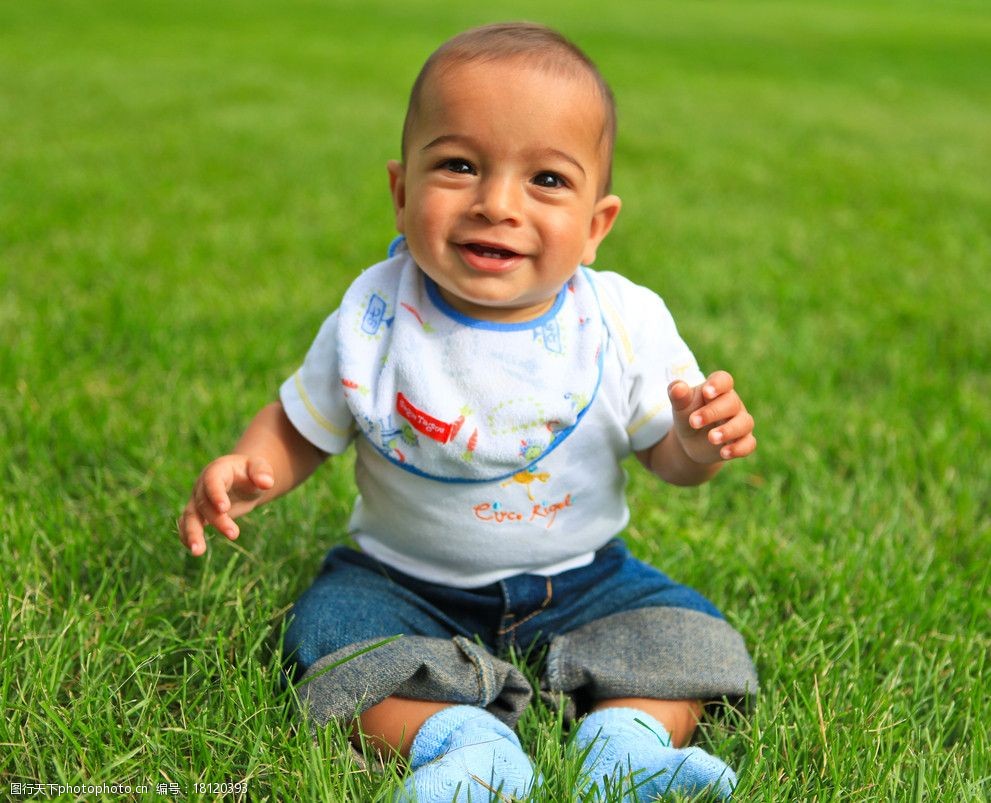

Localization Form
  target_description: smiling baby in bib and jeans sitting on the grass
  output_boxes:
[180,23,757,803]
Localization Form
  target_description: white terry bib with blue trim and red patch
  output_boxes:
[338,250,605,482]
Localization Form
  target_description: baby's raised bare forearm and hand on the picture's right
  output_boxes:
[637,371,757,485]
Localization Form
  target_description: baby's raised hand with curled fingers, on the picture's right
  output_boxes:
[668,371,757,464]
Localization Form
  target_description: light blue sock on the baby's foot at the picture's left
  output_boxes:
[397,705,534,803]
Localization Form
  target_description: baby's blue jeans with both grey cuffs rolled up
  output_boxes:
[285,539,757,724]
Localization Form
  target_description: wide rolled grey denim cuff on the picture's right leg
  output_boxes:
[544,607,757,709]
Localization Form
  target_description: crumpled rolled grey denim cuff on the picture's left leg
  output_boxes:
[296,636,533,727]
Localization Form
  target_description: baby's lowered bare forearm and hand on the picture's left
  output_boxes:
[179,402,327,555]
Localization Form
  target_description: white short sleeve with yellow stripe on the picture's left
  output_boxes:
[279,311,355,454]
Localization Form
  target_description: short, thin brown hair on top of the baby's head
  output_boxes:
[402,22,616,194]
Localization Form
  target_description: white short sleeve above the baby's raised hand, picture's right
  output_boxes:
[602,274,705,451]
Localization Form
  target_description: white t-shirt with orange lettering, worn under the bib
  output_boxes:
[281,254,704,588]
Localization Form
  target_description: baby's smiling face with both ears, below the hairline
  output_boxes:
[389,60,620,322]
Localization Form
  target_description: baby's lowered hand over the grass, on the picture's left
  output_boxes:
[179,454,275,556]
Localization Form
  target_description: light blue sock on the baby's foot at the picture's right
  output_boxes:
[575,708,736,803]
